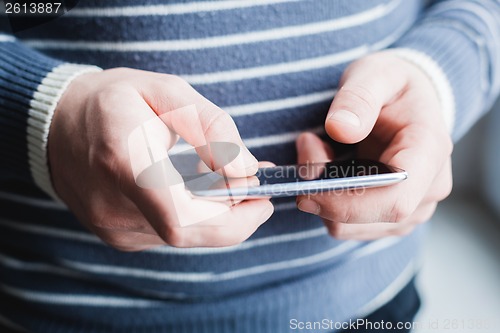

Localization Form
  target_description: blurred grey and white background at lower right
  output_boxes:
[415,99,500,333]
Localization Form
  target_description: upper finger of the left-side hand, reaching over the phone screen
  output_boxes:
[146,80,258,177]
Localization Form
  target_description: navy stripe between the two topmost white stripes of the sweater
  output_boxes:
[18,0,390,41]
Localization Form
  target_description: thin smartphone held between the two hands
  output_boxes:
[183,159,408,199]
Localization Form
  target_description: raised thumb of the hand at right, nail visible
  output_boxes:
[325,54,406,144]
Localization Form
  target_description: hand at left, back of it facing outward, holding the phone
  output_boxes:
[48,69,273,251]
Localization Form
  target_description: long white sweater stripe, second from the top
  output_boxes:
[24,0,401,52]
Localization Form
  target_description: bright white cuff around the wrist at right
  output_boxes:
[384,48,455,134]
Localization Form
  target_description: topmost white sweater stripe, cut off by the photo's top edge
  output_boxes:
[65,0,300,18]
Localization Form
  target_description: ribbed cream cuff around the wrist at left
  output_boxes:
[27,64,102,200]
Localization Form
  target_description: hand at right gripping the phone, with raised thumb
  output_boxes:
[297,52,453,240]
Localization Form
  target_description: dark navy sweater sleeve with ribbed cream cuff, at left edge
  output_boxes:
[0,33,100,198]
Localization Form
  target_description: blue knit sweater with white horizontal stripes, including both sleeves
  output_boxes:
[0,0,500,333]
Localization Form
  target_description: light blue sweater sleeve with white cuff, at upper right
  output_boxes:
[390,0,500,141]
